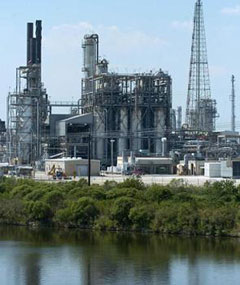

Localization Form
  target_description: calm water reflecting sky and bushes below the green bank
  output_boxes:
[0,227,240,285]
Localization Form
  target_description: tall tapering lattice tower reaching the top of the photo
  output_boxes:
[186,0,217,132]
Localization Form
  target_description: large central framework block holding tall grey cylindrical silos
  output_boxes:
[81,35,172,165]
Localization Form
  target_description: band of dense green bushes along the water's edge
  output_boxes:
[0,178,240,236]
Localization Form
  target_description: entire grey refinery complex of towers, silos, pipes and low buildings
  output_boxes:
[0,0,240,178]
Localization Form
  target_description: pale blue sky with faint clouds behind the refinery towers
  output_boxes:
[0,0,240,130]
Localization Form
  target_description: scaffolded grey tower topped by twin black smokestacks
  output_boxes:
[7,21,48,164]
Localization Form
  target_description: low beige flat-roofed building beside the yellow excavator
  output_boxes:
[45,158,100,176]
